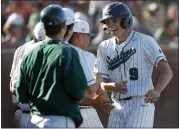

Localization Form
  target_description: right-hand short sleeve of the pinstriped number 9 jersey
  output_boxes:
[142,37,167,67]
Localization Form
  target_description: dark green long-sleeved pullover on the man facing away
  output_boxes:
[17,40,87,127]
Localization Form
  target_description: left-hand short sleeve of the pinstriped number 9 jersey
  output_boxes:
[93,44,110,79]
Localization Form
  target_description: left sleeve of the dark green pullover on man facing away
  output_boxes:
[17,57,29,103]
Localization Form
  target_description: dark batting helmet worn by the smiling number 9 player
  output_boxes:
[100,2,133,29]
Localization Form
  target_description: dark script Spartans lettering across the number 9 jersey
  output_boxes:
[106,48,136,71]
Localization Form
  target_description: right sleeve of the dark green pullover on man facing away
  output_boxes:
[63,48,88,101]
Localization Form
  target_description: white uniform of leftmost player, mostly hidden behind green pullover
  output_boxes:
[10,40,43,128]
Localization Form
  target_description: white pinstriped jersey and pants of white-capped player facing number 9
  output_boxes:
[66,42,103,128]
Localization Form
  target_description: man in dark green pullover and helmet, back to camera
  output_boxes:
[17,5,87,128]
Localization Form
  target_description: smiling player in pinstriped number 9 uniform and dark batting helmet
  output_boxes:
[95,2,173,128]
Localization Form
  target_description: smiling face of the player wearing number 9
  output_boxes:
[104,18,124,37]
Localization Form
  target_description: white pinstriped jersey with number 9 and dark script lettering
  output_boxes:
[95,31,167,99]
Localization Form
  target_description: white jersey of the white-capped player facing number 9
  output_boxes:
[65,42,96,86]
